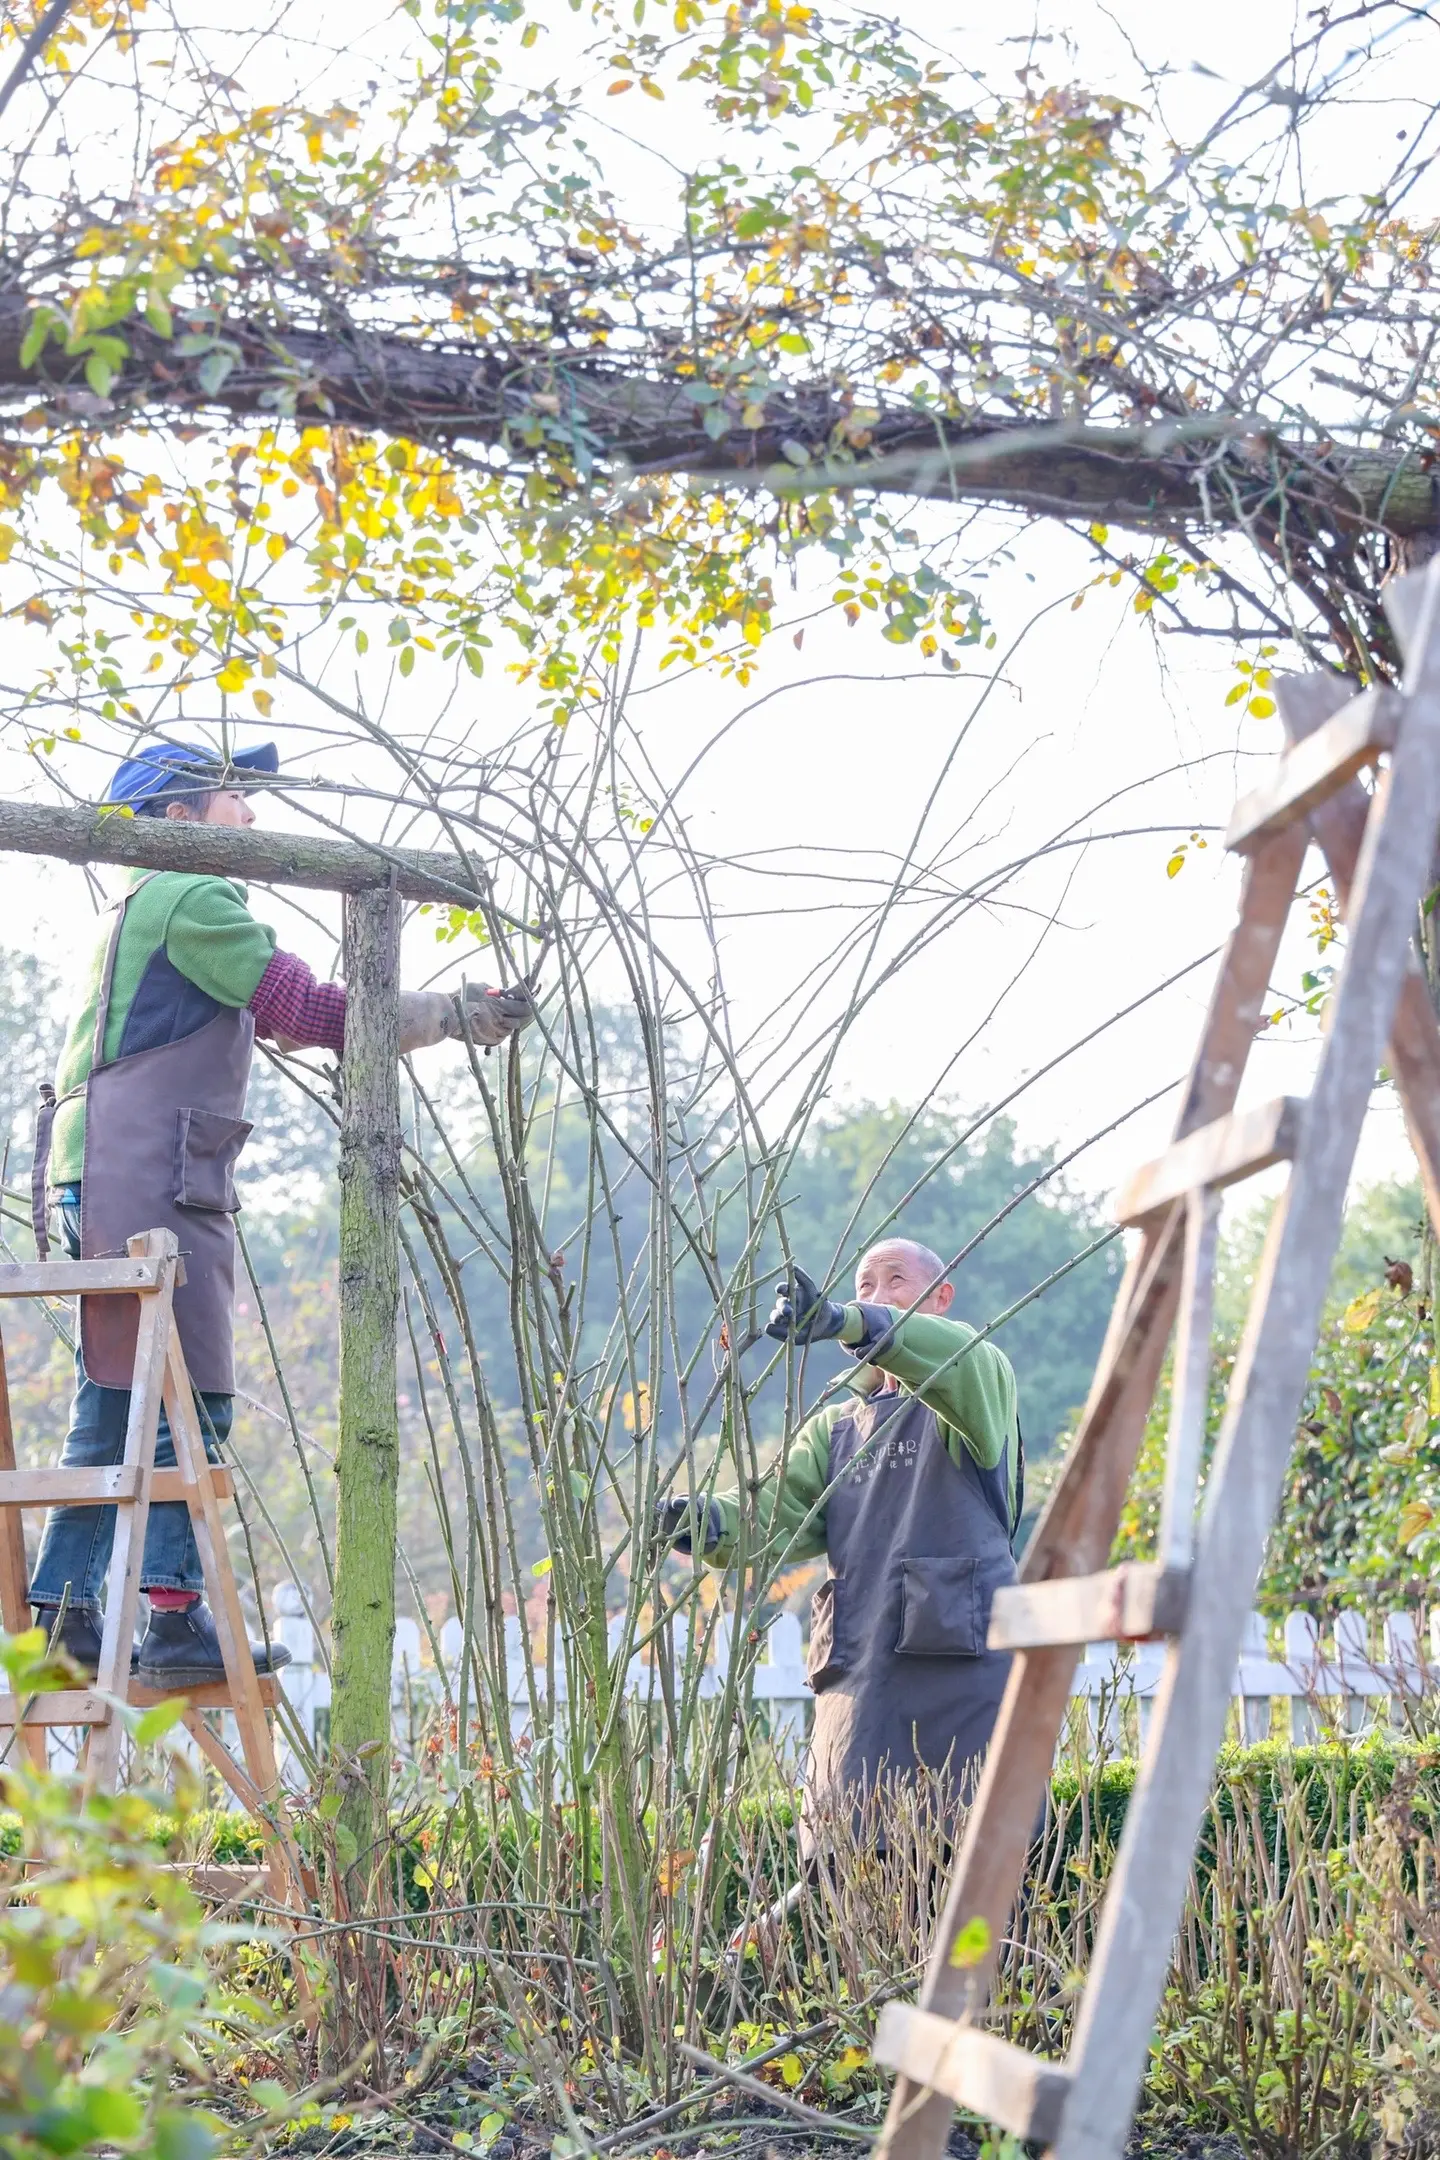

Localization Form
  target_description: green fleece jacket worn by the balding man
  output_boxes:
[706,1305,1019,1568]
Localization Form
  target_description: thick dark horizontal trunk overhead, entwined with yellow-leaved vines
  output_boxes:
[0,292,1436,536]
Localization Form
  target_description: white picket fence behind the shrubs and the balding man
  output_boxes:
[272,1583,1440,1782]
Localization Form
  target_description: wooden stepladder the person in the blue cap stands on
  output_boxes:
[0,1229,300,1905]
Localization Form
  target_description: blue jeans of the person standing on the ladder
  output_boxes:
[30,1186,235,1611]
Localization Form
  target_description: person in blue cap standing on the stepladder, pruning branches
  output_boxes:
[30,743,531,1689]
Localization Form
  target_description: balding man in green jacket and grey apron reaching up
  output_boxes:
[656,1238,1023,1851]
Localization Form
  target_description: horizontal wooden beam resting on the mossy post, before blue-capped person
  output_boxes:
[0,801,484,907]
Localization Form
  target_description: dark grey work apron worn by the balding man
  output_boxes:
[801,1391,1015,1849]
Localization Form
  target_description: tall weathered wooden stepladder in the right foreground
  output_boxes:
[874,557,1440,2160]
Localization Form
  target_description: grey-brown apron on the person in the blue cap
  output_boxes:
[41,877,255,1395]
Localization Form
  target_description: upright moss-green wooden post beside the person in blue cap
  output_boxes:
[330,886,399,1888]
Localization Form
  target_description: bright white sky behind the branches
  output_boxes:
[0,0,1408,1218]
